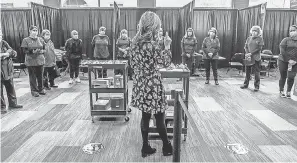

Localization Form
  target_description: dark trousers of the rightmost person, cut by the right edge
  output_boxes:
[278,60,297,92]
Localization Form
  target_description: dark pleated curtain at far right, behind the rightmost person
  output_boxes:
[263,10,297,55]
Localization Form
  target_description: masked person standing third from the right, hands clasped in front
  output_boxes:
[202,28,220,85]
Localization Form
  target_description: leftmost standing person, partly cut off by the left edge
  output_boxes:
[0,31,23,114]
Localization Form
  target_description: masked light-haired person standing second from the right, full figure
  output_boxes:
[240,26,264,92]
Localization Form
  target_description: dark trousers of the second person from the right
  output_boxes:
[244,61,261,88]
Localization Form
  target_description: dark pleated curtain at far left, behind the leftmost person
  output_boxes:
[1,9,32,62]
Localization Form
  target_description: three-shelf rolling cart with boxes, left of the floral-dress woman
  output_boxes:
[81,60,131,123]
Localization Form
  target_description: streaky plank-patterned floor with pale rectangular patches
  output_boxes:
[1,71,297,162]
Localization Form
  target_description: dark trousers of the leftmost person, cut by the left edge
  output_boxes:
[1,78,17,108]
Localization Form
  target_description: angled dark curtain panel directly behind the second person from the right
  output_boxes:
[235,5,266,52]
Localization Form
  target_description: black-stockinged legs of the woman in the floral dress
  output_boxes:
[140,112,168,144]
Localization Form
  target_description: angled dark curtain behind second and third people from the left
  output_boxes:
[31,2,61,48]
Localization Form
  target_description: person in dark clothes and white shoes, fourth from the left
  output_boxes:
[65,30,82,84]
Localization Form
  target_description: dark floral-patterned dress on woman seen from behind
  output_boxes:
[131,41,171,114]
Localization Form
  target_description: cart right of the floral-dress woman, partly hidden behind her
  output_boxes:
[149,68,190,141]
